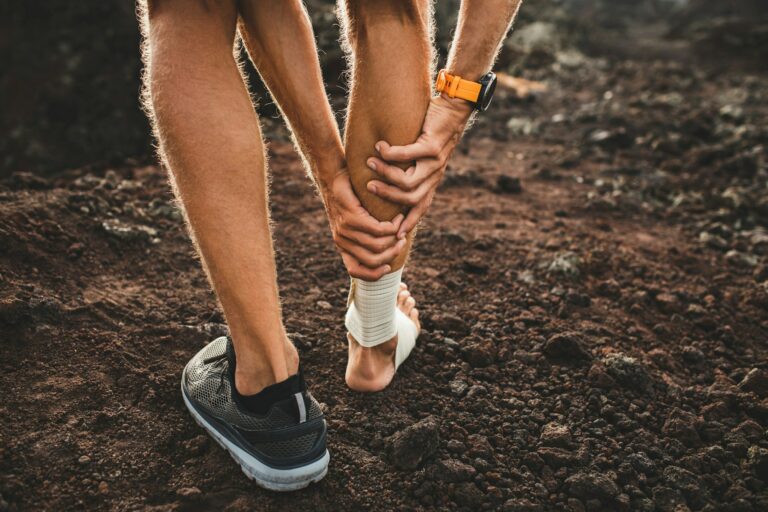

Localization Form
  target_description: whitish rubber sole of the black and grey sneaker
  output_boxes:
[181,384,331,492]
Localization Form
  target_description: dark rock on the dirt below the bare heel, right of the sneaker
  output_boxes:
[387,416,440,470]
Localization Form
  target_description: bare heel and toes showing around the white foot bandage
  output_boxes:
[345,283,421,392]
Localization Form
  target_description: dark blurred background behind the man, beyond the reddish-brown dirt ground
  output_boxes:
[0,0,768,176]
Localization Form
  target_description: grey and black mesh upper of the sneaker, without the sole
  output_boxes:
[183,337,325,466]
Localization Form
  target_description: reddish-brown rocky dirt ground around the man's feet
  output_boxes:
[0,14,768,512]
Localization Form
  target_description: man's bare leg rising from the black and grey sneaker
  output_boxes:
[140,0,299,395]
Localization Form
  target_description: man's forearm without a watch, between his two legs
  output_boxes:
[240,0,344,191]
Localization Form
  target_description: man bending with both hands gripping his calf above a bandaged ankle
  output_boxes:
[140,0,517,490]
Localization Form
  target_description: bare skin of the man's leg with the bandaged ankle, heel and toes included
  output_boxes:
[339,0,432,391]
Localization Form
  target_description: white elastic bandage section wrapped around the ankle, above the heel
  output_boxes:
[345,268,403,347]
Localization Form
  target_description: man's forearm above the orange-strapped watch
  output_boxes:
[447,0,521,81]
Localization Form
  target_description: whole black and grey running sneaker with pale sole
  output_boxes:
[181,337,330,491]
